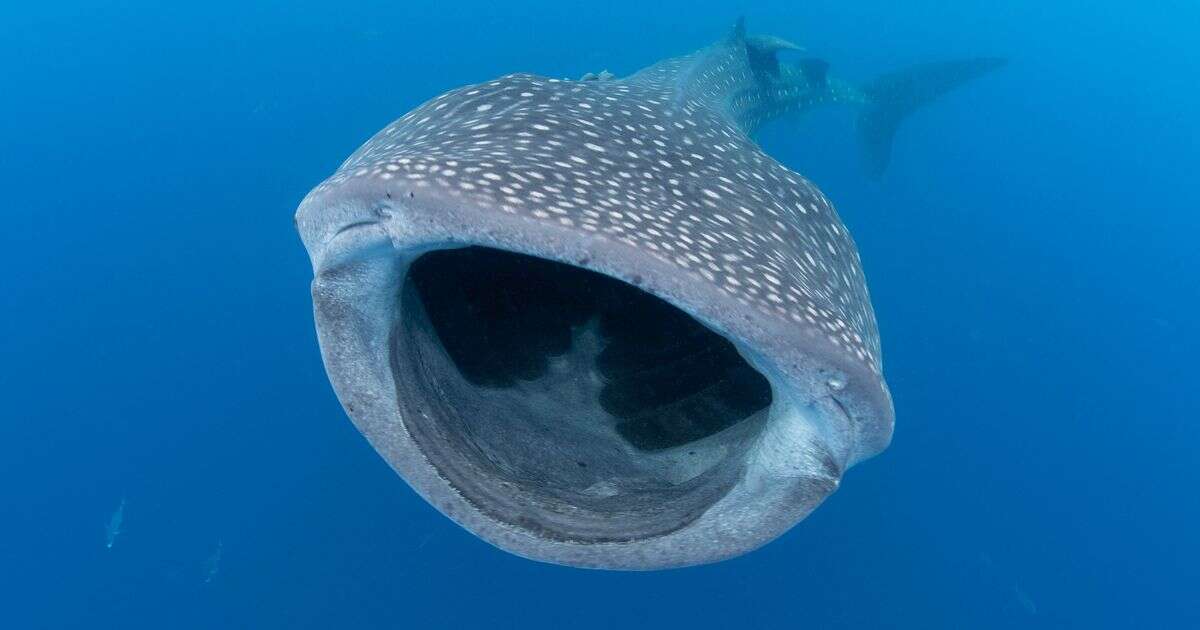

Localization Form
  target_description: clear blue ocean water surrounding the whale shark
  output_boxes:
[0,0,1200,629]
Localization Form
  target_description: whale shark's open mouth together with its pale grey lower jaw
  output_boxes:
[313,216,848,569]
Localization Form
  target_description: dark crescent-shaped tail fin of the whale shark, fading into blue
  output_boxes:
[858,58,1007,178]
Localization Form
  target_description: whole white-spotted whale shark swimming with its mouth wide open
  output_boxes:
[295,22,1002,570]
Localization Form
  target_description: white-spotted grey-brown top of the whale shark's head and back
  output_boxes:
[311,42,882,374]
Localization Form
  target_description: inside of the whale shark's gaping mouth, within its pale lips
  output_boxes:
[390,246,773,542]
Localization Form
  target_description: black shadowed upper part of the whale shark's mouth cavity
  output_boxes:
[409,247,772,451]
